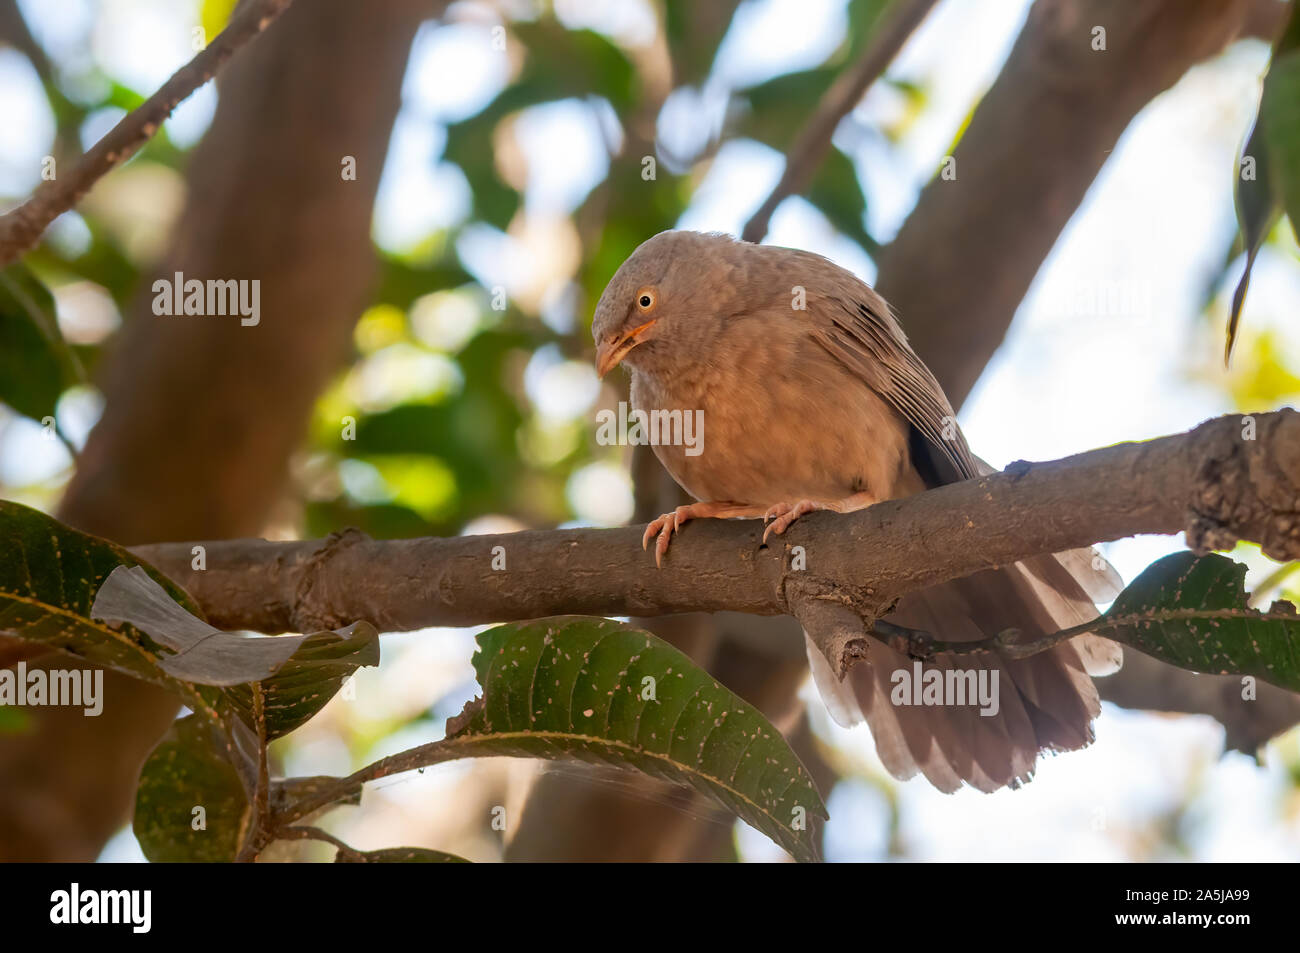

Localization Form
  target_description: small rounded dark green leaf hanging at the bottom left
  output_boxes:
[131,715,248,863]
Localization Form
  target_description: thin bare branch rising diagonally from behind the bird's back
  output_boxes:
[741,0,936,242]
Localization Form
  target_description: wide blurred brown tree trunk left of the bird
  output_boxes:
[0,0,441,861]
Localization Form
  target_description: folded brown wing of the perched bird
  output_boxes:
[809,287,980,482]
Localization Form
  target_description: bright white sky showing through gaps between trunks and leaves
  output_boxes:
[0,0,1300,859]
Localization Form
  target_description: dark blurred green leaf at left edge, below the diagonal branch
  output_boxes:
[0,264,81,420]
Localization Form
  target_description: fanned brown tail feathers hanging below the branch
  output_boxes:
[807,550,1121,792]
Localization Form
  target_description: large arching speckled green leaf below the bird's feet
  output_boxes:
[452,616,827,861]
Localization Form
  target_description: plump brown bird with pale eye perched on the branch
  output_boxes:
[592,230,1122,793]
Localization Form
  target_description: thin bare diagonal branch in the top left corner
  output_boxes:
[0,0,293,268]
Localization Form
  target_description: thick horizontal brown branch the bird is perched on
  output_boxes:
[135,410,1300,632]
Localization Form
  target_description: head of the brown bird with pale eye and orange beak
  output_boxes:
[592,231,741,377]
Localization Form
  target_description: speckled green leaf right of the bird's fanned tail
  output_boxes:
[1089,553,1300,692]
